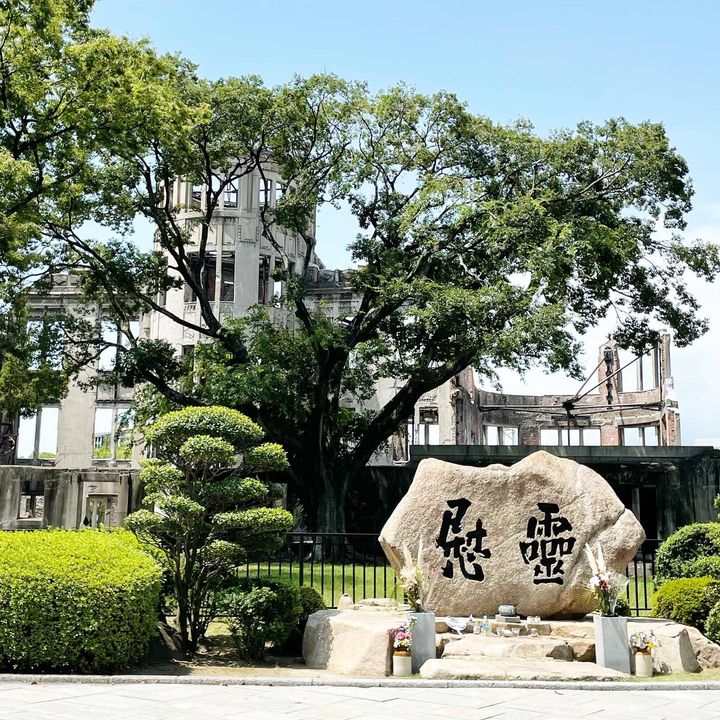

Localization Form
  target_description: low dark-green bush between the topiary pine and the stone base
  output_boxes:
[219,578,302,660]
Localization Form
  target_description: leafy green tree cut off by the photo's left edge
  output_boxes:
[0,0,194,417]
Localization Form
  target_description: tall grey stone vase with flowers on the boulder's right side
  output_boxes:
[585,544,630,675]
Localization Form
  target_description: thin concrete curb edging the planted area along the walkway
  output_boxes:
[0,673,720,691]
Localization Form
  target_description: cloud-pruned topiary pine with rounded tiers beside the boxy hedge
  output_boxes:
[125,407,292,652]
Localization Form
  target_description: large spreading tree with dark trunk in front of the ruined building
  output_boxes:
[2,8,720,530]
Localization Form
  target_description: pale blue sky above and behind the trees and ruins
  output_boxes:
[94,0,720,444]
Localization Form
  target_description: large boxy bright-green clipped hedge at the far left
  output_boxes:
[0,530,160,673]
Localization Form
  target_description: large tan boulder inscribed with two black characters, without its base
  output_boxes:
[380,451,645,618]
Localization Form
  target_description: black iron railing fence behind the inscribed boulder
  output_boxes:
[240,532,657,615]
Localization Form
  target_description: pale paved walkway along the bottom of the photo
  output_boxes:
[0,682,720,720]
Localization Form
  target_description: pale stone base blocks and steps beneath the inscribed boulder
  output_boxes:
[303,608,720,680]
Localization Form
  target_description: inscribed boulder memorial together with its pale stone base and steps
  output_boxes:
[303,451,720,680]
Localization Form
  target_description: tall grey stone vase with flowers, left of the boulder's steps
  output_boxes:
[399,541,440,673]
